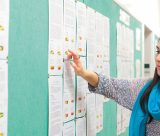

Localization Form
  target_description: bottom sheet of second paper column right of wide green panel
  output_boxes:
[63,121,75,136]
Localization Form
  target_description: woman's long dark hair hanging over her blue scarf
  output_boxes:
[140,68,160,123]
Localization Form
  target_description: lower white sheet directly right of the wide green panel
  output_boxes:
[49,76,62,136]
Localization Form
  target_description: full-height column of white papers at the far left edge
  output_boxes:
[0,0,9,136]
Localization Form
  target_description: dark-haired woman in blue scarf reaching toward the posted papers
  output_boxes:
[68,40,160,136]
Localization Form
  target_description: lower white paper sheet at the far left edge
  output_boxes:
[0,60,8,136]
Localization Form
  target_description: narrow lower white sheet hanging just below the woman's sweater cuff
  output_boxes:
[87,93,96,136]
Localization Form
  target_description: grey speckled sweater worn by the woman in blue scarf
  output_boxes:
[88,74,160,136]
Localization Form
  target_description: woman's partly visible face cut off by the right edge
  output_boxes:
[155,42,160,76]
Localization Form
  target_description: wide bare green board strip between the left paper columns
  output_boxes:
[8,0,48,136]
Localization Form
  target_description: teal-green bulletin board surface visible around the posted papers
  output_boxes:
[8,0,142,136]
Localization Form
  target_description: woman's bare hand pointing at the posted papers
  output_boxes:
[67,50,85,77]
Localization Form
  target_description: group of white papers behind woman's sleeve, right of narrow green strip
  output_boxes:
[117,23,134,135]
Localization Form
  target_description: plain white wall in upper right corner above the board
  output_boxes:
[114,0,160,35]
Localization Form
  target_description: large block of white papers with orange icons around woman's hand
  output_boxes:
[48,0,110,136]
